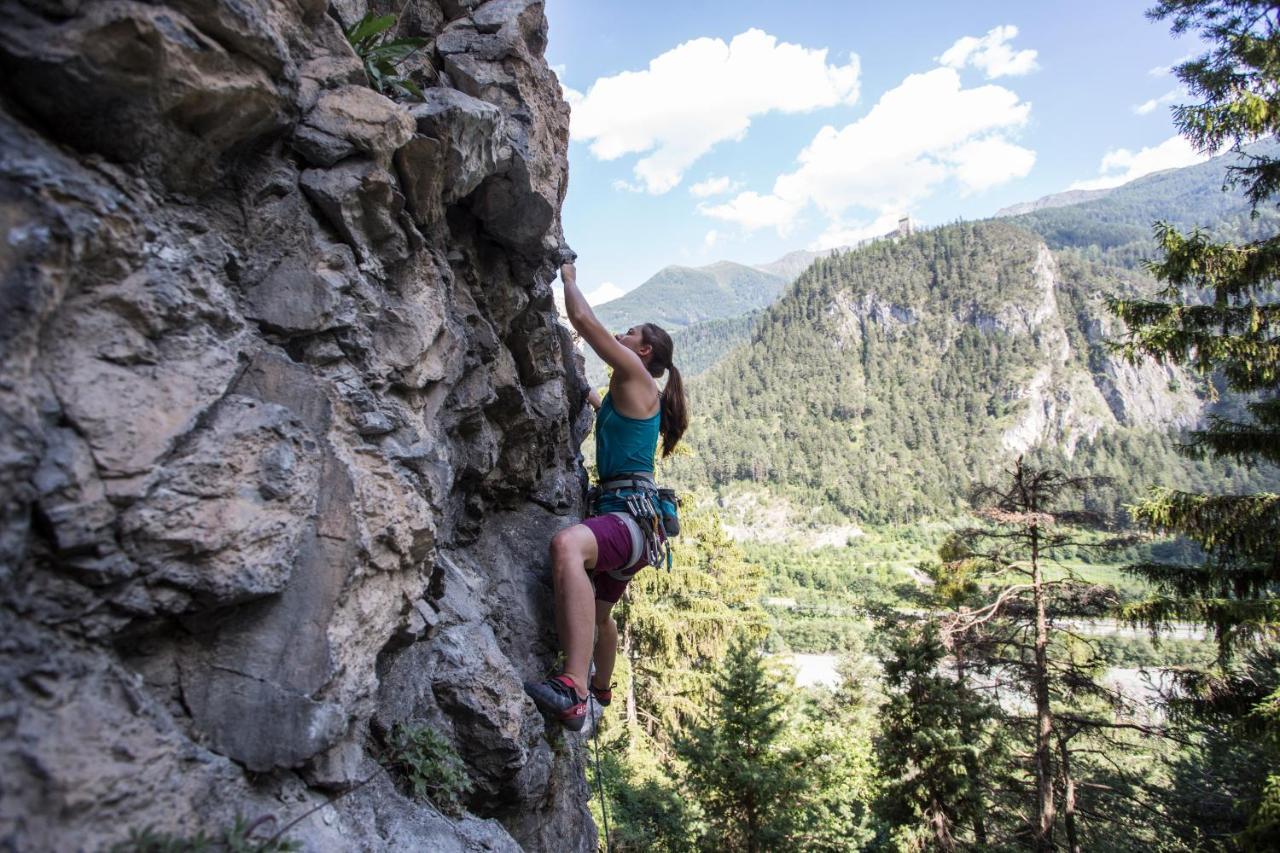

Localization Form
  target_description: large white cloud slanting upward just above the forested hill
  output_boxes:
[699,68,1036,234]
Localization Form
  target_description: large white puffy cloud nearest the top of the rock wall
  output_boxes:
[566,29,859,195]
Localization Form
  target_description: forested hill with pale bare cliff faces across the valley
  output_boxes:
[675,220,1274,523]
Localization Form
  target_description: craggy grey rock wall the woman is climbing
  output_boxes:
[0,0,595,850]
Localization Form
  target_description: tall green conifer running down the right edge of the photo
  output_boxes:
[1112,0,1280,843]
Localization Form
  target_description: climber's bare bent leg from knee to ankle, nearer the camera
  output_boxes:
[550,524,593,698]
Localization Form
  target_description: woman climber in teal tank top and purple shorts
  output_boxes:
[525,263,689,731]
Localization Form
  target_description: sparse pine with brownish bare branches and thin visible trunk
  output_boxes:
[932,459,1156,850]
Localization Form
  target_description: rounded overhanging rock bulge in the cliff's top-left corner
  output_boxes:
[0,0,292,188]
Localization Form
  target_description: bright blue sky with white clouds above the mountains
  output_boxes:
[547,0,1199,301]
